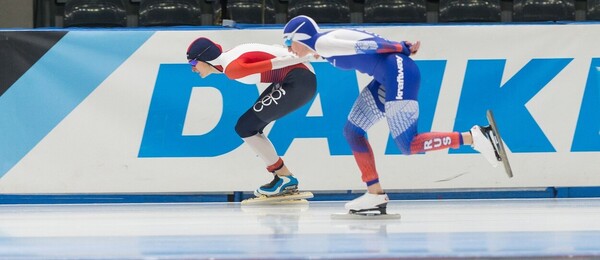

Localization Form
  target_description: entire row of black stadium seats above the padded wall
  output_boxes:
[64,0,600,27]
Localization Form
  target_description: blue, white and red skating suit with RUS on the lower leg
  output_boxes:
[302,29,462,185]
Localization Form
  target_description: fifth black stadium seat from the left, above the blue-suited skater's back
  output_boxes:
[363,0,427,23]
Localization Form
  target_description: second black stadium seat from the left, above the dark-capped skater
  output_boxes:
[138,0,202,26]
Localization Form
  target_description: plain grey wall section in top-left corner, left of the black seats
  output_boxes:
[0,0,34,28]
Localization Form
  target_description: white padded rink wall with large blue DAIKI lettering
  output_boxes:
[0,23,600,200]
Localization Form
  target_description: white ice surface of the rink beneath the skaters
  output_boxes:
[0,198,600,259]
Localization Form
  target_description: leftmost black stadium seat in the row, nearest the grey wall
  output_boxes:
[63,0,127,27]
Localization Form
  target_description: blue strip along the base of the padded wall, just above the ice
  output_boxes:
[0,187,600,205]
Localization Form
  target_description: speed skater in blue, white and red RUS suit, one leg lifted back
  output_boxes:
[283,16,498,214]
